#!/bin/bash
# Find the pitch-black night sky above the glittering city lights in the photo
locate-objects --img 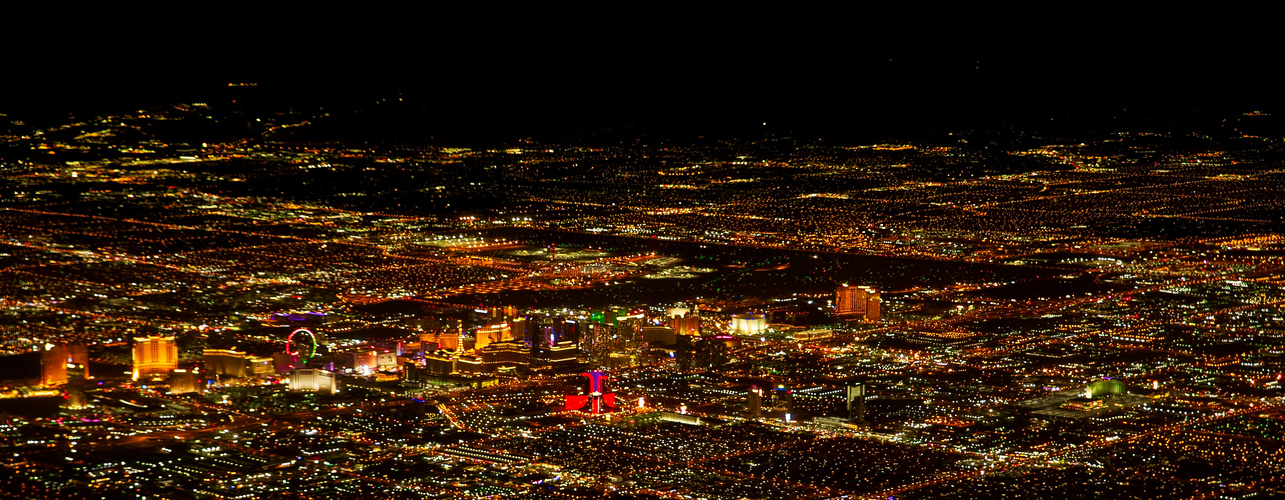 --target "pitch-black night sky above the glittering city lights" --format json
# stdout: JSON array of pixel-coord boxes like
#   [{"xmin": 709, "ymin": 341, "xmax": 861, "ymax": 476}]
[{"xmin": 0, "ymin": 13, "xmax": 1281, "ymax": 139}]
